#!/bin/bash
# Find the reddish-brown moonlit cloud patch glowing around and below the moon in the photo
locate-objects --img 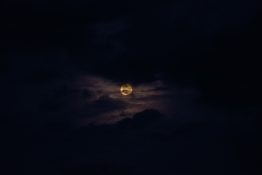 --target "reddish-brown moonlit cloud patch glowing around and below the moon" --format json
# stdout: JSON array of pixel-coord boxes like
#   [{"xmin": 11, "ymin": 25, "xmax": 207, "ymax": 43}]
[{"xmin": 68, "ymin": 75, "xmax": 178, "ymax": 125}]
